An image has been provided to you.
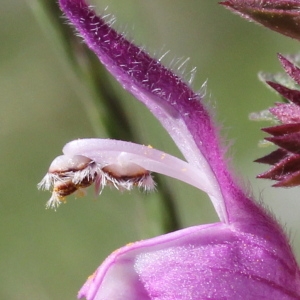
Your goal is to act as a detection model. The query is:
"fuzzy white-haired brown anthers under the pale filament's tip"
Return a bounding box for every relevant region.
[38,155,155,209]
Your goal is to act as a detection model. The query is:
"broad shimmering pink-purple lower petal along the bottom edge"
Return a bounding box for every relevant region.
[78,223,300,300]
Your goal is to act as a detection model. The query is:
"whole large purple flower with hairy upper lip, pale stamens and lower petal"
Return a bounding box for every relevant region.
[41,0,300,300]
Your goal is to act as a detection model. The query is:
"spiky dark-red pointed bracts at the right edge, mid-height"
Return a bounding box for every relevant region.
[256,55,300,187]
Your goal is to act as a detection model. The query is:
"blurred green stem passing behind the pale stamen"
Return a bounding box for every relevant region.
[28,0,181,232]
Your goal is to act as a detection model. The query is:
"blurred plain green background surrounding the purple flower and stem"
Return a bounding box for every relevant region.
[0,0,300,300]
